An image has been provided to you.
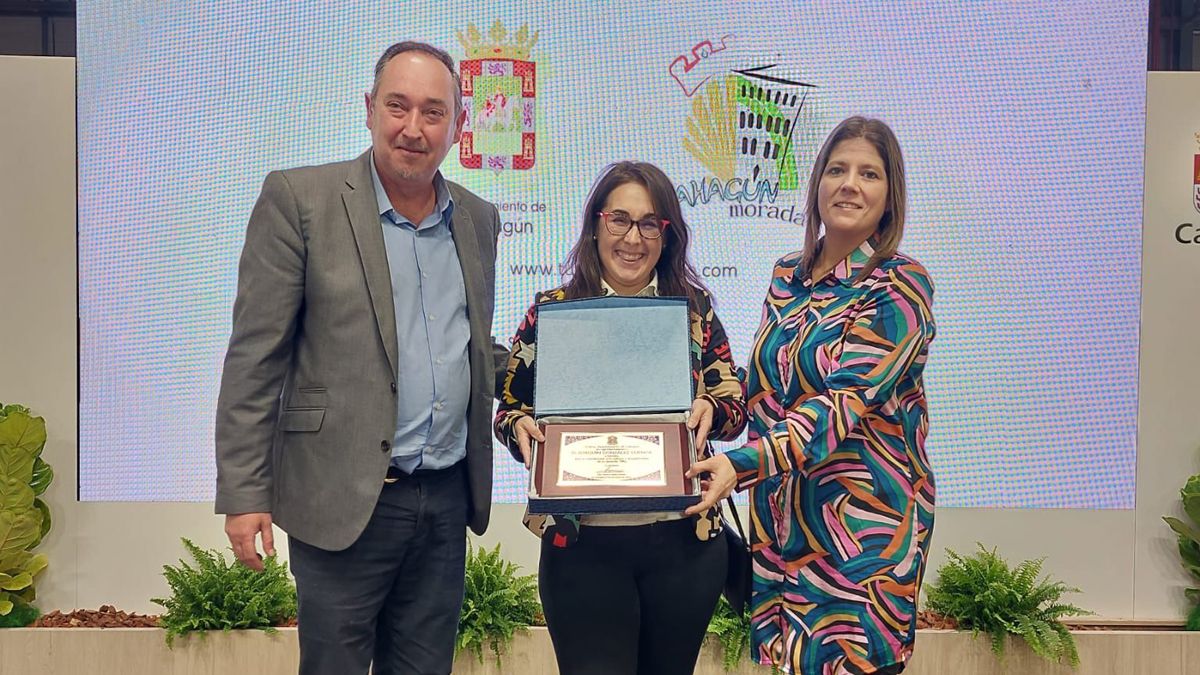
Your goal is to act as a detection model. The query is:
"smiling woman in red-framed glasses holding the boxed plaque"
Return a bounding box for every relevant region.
[496,162,745,675]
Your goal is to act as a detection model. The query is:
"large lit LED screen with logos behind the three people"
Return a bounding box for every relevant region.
[78,0,1146,508]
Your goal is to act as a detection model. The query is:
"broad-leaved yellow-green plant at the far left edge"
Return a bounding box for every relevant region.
[0,404,54,627]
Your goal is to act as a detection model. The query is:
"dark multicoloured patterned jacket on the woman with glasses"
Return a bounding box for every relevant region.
[494,281,746,546]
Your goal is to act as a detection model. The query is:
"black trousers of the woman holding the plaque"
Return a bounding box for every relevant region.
[538,518,728,675]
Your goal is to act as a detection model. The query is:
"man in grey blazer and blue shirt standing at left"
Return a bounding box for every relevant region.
[216,42,504,675]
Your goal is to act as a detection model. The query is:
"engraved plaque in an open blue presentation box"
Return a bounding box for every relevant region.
[529,297,700,513]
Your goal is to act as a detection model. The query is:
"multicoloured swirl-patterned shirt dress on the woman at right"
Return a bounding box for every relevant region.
[728,241,935,675]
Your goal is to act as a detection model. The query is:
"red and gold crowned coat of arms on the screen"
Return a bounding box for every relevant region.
[458,20,538,171]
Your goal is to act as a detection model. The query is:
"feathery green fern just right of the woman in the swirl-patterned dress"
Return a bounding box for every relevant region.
[925,544,1091,667]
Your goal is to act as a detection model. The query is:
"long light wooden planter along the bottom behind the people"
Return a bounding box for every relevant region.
[0,628,1200,675]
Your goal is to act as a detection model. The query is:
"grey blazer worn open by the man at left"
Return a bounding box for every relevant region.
[216,153,506,550]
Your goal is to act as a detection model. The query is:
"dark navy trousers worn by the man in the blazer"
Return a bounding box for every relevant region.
[288,462,468,675]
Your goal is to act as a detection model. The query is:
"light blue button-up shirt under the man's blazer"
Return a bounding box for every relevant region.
[371,156,470,473]
